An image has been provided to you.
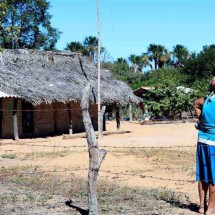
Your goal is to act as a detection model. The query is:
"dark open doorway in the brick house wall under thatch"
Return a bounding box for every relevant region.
[22,101,34,137]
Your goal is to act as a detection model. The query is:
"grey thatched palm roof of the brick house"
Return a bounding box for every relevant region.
[0,49,139,105]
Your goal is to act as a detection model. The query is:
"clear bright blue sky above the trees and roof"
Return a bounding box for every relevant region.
[49,0,215,59]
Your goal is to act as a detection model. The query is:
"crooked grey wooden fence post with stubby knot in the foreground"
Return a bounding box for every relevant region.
[81,84,107,215]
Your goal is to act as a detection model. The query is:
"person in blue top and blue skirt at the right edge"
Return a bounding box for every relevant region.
[194,77,215,215]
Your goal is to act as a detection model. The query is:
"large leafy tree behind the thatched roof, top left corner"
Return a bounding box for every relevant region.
[0,0,60,49]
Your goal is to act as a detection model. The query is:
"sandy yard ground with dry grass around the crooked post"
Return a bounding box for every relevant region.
[0,123,198,215]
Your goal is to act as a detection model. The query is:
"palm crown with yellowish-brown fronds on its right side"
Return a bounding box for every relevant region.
[147,44,170,69]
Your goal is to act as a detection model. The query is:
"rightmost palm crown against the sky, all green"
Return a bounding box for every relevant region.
[172,45,189,66]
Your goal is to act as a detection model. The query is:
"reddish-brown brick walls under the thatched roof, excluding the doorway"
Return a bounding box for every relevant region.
[2,98,98,138]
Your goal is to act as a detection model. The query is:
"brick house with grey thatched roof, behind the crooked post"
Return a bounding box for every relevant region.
[0,49,140,138]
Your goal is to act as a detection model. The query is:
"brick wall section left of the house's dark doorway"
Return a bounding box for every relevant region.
[2,98,22,138]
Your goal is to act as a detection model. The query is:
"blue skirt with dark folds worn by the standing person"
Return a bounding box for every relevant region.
[196,143,215,185]
